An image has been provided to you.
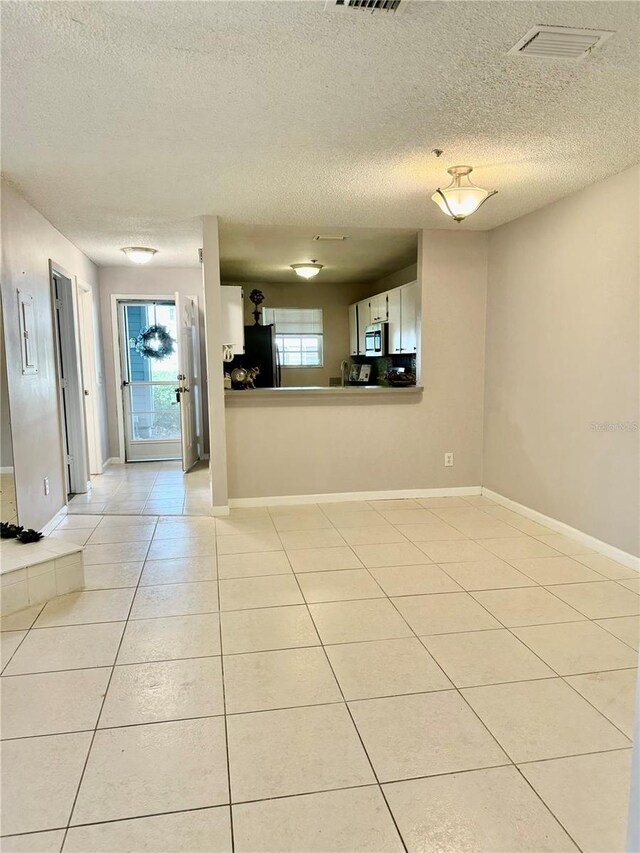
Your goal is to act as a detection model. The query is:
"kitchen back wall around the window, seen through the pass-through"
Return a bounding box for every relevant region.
[225,276,396,387]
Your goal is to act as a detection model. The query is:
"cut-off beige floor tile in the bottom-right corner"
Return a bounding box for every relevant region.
[520,749,631,853]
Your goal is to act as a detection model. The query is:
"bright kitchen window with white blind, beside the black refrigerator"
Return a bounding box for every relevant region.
[262,308,323,367]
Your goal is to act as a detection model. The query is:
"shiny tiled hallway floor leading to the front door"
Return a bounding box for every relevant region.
[69,461,211,516]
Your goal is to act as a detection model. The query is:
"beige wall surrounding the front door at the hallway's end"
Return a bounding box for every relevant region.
[98,270,209,457]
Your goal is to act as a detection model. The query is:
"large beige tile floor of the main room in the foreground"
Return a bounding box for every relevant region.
[1,496,640,853]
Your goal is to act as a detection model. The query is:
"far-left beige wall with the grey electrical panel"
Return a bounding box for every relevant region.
[2,183,97,529]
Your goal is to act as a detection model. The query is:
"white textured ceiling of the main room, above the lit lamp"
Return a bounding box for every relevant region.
[0,0,640,266]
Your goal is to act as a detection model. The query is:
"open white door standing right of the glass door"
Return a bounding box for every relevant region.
[176,293,200,471]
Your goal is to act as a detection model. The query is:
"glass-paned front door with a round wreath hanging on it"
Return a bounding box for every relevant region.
[118,300,182,462]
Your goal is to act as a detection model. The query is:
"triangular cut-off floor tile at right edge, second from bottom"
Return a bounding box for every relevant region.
[567,661,638,738]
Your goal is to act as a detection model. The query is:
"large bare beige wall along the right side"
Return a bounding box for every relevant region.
[483,167,640,554]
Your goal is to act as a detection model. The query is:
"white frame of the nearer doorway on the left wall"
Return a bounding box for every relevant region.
[49,258,91,502]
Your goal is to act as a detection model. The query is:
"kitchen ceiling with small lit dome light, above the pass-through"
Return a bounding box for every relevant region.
[220,222,418,284]
